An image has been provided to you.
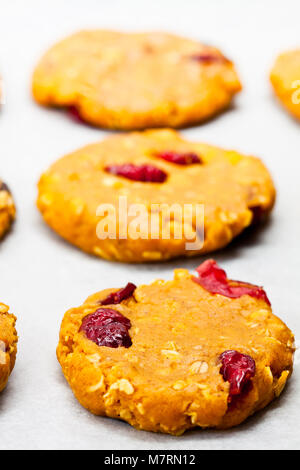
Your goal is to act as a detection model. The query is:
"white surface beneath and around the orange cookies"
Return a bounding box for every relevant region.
[0,0,300,449]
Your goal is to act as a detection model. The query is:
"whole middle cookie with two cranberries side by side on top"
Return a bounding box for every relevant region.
[38,130,275,262]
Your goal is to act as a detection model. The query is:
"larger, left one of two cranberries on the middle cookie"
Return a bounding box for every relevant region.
[105,163,167,183]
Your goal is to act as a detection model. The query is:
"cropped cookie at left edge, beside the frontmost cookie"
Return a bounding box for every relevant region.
[0,303,18,392]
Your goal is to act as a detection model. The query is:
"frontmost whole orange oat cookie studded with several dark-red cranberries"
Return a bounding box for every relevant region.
[57,260,294,434]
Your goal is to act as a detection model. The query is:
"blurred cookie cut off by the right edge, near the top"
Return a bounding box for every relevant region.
[270,49,300,119]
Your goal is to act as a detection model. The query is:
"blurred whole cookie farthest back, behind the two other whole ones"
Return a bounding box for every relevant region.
[33,31,241,129]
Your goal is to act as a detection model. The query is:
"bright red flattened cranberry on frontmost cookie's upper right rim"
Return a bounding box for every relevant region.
[193,259,271,305]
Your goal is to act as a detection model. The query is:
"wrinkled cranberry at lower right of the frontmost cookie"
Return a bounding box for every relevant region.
[219,350,256,403]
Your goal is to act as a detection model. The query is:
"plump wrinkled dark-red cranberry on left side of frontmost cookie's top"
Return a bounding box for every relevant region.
[79,308,132,348]
